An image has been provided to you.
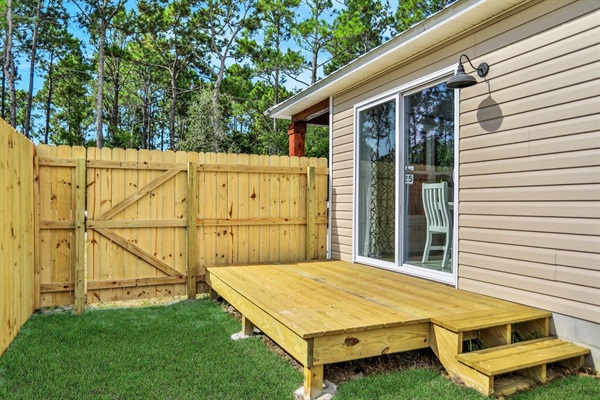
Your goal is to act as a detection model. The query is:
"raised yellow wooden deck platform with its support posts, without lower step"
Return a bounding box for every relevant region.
[206,261,584,398]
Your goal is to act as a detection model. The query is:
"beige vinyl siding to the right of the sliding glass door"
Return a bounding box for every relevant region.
[458,4,600,323]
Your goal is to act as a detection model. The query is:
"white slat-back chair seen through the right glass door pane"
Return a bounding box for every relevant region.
[422,182,452,269]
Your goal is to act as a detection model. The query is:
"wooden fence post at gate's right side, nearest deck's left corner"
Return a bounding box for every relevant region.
[186,162,198,299]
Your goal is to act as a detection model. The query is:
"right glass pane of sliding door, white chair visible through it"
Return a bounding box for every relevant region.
[402,83,454,272]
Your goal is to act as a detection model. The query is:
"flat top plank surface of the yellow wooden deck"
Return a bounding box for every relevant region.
[208,261,524,339]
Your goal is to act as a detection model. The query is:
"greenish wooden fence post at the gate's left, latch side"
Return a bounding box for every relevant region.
[75,158,86,314]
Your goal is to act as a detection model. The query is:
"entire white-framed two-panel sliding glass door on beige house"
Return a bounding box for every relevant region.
[354,77,455,281]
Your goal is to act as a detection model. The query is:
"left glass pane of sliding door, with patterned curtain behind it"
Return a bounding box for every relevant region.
[356,99,396,262]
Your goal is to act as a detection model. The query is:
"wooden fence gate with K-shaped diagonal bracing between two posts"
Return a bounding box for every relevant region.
[87,148,188,303]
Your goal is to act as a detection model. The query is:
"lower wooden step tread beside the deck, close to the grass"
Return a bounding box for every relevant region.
[456,338,590,376]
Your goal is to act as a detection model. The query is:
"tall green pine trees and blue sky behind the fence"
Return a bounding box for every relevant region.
[0,0,450,157]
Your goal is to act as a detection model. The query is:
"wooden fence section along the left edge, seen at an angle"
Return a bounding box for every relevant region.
[0,119,35,354]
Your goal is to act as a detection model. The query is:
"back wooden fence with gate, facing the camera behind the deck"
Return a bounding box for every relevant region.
[36,145,328,311]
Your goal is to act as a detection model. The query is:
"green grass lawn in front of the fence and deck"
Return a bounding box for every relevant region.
[0,300,600,400]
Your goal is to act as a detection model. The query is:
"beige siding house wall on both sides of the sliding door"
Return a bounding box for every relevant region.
[331,1,600,365]
